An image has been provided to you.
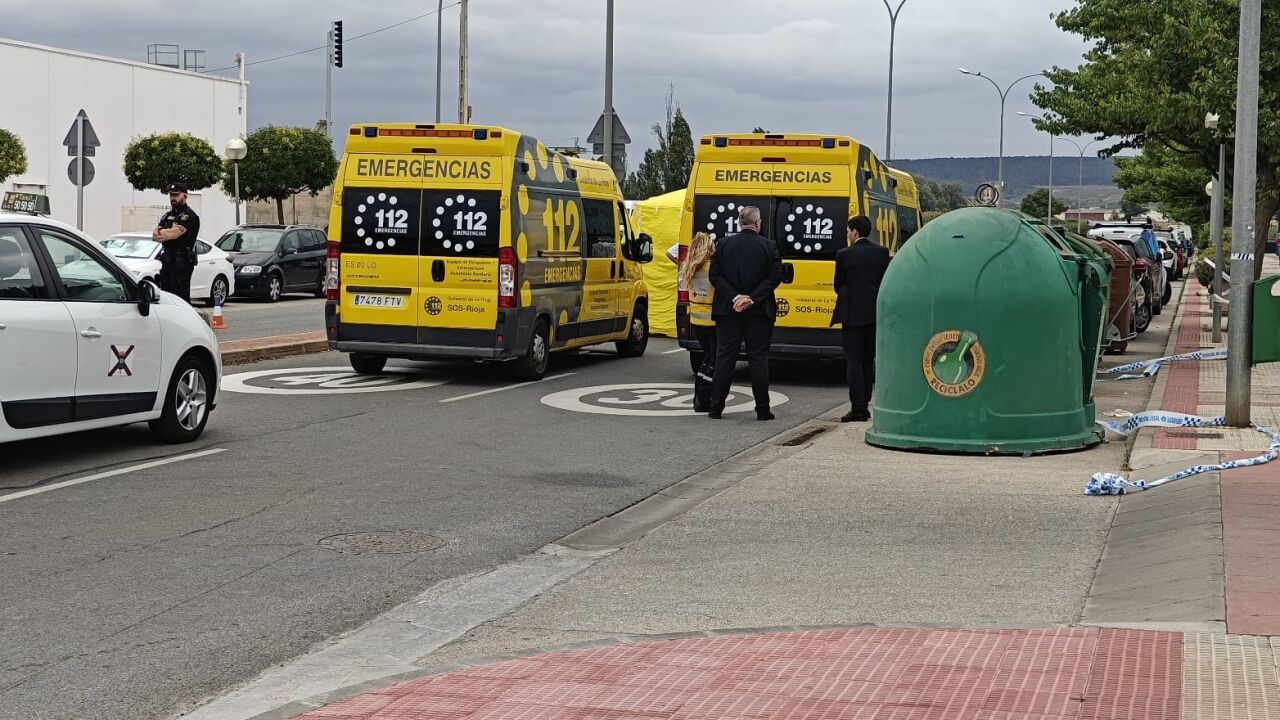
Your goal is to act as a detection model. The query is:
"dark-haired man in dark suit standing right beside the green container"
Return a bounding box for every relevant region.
[831,215,888,423]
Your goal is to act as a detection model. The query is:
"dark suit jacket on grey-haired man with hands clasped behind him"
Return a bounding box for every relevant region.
[710,231,782,319]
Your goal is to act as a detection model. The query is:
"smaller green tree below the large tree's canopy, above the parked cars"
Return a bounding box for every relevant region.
[1115,145,1212,225]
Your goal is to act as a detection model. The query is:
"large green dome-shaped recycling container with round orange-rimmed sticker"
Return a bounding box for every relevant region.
[867,208,1110,454]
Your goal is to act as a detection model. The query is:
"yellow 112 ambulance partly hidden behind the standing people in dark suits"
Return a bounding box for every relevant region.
[676,133,920,370]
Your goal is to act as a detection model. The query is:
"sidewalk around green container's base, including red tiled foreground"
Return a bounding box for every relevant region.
[189,271,1280,720]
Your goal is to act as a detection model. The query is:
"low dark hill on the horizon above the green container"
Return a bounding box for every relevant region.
[893,155,1123,206]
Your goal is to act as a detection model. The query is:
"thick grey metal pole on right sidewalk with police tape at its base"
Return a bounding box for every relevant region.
[1226,0,1262,428]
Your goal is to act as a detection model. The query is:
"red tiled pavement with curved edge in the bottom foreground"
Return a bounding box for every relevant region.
[302,628,1183,720]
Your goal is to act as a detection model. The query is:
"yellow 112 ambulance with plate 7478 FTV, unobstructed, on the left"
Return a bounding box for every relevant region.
[325,124,653,379]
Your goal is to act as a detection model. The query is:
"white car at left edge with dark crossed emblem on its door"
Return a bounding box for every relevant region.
[0,213,223,443]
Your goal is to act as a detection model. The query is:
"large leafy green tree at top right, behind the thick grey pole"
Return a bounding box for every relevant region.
[1033,0,1280,275]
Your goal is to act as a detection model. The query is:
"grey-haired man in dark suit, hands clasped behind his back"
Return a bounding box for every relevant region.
[708,206,782,420]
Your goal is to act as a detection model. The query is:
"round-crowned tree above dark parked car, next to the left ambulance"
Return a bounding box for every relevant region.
[223,126,338,224]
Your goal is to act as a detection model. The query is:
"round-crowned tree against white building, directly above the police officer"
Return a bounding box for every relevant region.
[124,132,223,192]
